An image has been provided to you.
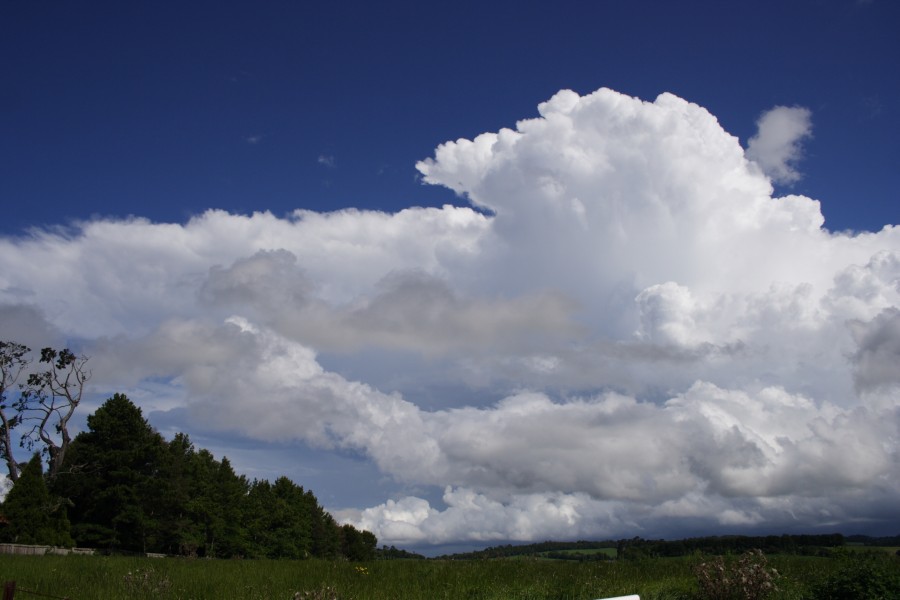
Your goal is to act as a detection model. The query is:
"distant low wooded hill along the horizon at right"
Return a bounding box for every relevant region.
[441,533,856,560]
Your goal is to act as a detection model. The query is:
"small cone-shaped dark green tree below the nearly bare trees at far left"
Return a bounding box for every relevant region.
[0,453,75,546]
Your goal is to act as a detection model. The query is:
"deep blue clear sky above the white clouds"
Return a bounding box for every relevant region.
[0,0,900,234]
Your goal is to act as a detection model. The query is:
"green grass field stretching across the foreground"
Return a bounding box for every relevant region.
[0,555,897,600]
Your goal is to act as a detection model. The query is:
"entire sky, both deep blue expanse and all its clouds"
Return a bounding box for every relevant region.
[0,0,900,552]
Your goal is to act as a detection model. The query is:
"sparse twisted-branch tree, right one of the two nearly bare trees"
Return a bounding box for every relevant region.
[16,348,91,479]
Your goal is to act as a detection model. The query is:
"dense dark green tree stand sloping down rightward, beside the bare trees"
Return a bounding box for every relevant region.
[46,394,377,561]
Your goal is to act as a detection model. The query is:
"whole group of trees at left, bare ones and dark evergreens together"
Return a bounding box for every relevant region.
[0,342,377,560]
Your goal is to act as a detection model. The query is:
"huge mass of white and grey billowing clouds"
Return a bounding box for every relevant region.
[0,89,900,544]
